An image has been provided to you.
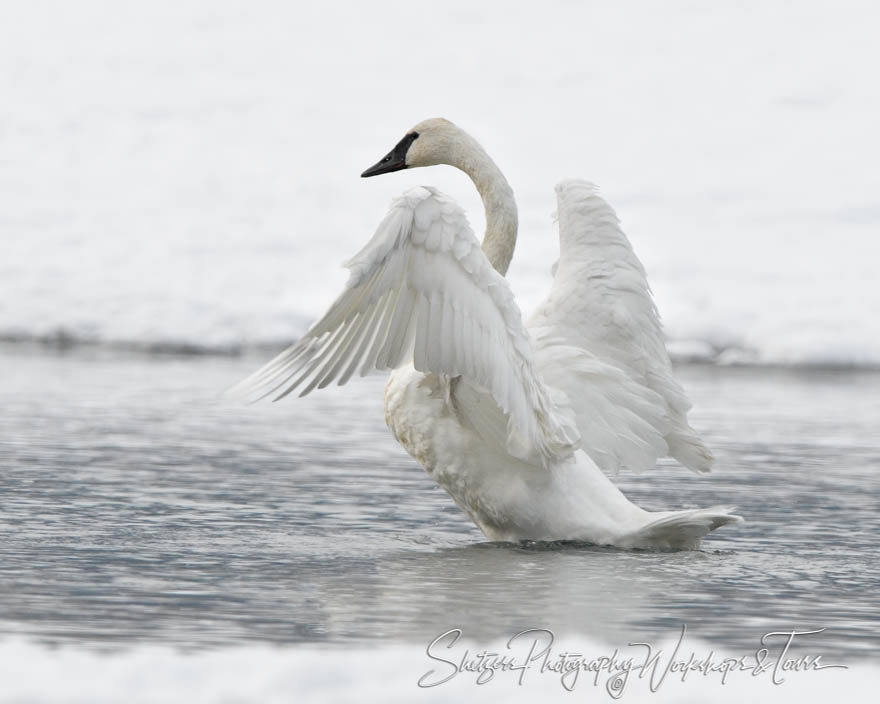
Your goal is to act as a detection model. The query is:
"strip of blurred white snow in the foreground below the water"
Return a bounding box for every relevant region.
[0,634,880,704]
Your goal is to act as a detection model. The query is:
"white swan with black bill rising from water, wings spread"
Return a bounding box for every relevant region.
[230,118,742,549]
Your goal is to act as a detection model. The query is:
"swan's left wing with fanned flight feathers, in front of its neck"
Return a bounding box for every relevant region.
[230,188,578,465]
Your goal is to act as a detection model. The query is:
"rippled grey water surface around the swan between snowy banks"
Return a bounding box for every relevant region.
[0,346,880,655]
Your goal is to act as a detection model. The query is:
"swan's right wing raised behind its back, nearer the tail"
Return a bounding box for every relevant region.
[528,180,712,472]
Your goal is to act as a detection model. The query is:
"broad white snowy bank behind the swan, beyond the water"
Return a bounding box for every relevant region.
[0,0,880,366]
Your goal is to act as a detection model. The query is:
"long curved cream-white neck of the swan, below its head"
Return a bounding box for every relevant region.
[450,131,519,276]
